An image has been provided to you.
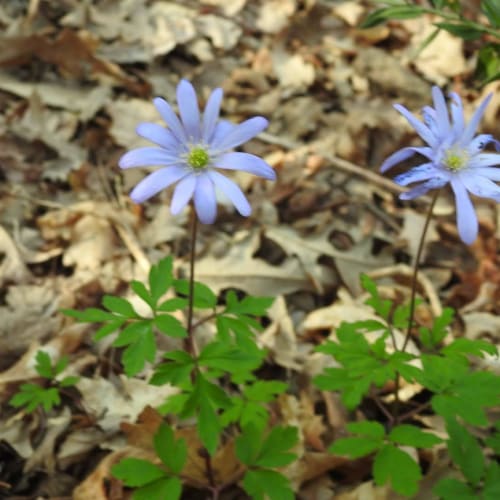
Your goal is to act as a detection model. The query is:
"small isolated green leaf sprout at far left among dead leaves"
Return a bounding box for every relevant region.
[9,351,79,413]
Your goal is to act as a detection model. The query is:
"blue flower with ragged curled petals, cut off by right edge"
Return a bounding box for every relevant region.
[380,87,500,245]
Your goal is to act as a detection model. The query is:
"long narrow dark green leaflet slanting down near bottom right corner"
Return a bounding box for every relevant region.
[446,418,485,486]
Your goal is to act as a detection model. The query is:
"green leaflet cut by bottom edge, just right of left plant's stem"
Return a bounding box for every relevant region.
[243,470,295,500]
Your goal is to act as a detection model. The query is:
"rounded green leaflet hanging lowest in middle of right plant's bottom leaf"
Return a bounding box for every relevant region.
[373,444,422,496]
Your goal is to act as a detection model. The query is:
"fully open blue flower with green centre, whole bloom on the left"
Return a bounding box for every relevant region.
[119,80,276,224]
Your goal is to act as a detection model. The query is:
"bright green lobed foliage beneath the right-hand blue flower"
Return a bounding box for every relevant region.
[314,276,500,500]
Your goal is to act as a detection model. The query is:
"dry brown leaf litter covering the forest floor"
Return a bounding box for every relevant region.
[0,0,500,500]
